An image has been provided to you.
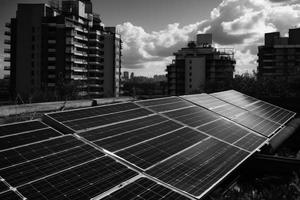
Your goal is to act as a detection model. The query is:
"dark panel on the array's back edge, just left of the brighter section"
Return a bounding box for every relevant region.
[136,97,193,112]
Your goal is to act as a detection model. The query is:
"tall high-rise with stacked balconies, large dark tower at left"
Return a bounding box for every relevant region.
[5,0,121,98]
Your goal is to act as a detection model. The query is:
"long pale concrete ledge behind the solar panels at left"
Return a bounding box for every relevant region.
[0,97,133,117]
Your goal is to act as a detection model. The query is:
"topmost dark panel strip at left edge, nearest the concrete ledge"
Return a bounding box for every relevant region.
[0,121,47,137]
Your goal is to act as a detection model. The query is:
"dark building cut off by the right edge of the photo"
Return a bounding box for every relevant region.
[257,28,300,81]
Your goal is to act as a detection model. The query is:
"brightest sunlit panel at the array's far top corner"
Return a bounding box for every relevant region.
[210,90,258,108]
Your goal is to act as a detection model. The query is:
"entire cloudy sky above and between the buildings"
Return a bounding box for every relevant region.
[0,0,300,76]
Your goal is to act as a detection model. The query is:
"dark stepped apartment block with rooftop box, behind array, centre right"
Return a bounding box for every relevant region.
[167,34,235,95]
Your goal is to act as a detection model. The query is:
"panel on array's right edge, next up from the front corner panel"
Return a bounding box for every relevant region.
[198,118,267,152]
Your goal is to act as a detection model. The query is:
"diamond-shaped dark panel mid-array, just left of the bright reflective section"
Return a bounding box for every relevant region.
[164,106,220,127]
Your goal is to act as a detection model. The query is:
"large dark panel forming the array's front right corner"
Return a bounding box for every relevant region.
[147,138,249,196]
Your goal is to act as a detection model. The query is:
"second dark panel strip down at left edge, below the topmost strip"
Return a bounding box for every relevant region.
[0,128,61,150]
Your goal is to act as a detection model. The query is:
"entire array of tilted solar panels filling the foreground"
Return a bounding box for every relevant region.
[0,91,294,200]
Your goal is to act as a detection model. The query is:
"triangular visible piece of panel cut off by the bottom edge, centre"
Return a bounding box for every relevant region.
[102,177,190,200]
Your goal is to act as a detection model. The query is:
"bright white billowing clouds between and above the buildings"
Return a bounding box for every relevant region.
[118,0,300,75]
